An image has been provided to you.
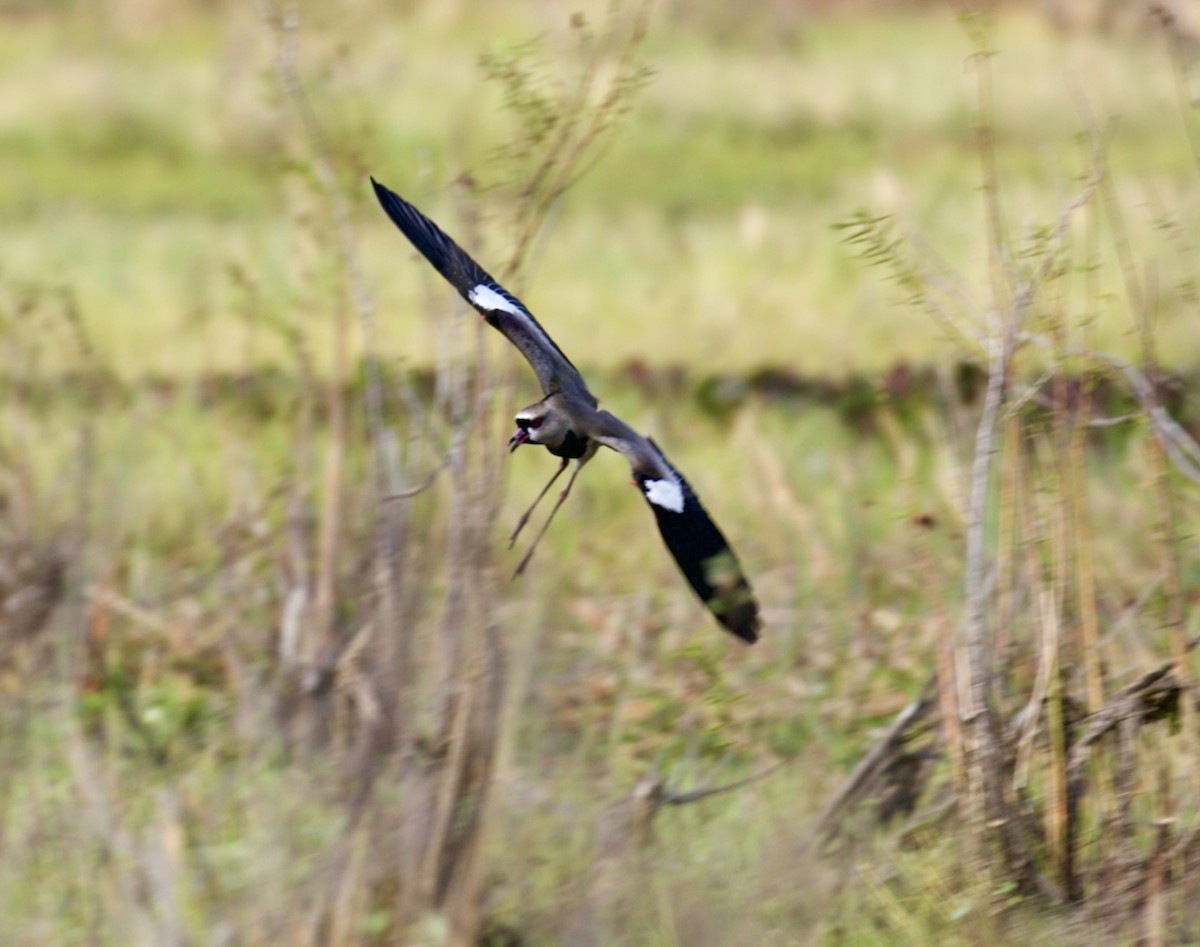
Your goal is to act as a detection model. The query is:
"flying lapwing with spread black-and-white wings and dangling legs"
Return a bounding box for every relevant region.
[371,178,760,642]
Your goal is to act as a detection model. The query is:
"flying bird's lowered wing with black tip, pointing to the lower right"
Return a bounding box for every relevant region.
[588,410,762,645]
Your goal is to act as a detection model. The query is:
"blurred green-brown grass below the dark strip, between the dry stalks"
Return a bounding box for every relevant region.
[7,367,1180,943]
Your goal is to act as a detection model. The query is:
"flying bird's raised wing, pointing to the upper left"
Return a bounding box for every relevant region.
[371,178,596,404]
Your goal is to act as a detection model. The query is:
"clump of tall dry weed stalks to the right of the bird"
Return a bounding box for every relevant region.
[847,10,1200,942]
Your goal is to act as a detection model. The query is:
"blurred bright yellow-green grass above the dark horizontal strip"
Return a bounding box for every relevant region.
[9,4,1195,376]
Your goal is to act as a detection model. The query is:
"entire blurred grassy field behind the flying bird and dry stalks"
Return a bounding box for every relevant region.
[0,0,1200,945]
